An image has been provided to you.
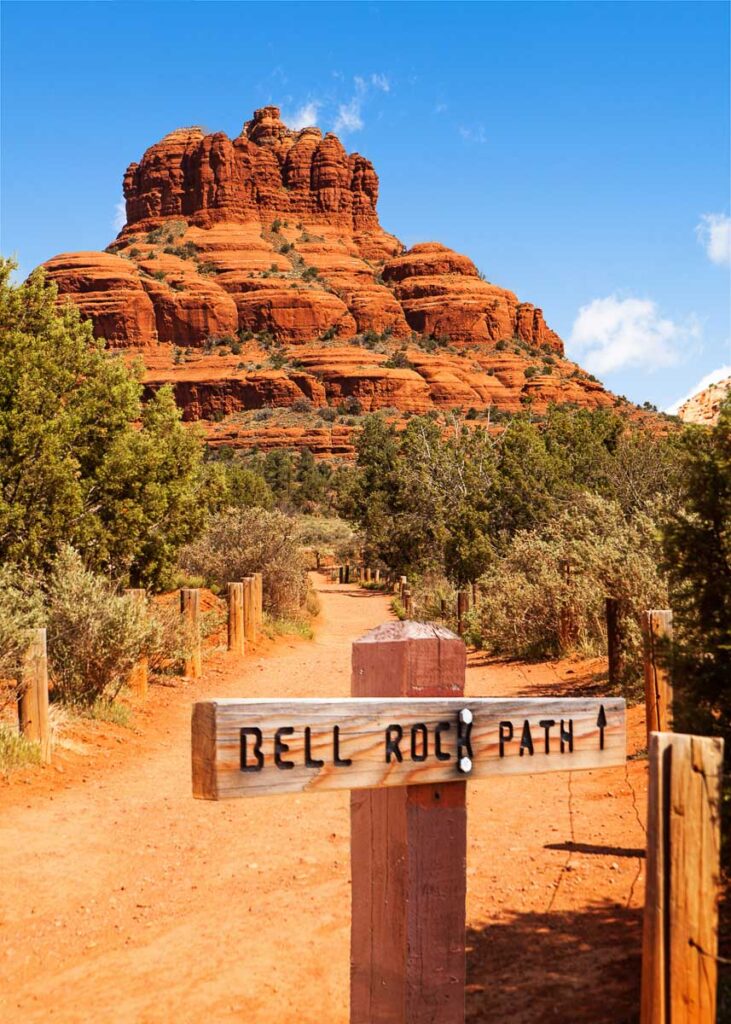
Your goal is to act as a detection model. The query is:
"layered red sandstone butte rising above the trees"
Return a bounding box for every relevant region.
[39,106,619,454]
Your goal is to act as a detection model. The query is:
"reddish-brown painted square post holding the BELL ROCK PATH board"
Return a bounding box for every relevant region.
[350,623,467,1024]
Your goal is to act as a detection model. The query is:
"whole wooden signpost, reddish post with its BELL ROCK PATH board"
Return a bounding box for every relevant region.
[192,622,626,1024]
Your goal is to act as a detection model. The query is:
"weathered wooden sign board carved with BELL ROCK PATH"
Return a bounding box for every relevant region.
[192,697,626,800]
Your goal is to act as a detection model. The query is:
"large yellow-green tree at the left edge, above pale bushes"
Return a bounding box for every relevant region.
[0,260,205,587]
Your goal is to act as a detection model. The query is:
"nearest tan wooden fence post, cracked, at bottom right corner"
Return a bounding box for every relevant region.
[641,732,723,1024]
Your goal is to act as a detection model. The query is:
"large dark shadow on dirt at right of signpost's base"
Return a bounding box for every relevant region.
[466,902,642,1024]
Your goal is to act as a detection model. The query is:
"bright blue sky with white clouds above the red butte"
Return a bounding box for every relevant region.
[0,0,731,408]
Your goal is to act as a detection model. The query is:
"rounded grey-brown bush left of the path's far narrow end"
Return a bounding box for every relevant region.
[180,508,307,615]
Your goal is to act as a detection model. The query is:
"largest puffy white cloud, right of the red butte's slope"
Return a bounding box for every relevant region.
[568,295,700,374]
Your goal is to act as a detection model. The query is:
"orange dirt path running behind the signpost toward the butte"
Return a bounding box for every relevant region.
[0,583,644,1024]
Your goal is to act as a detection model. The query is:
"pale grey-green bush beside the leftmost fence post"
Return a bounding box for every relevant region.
[46,548,153,706]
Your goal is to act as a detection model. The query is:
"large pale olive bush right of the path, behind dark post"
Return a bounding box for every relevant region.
[473,494,668,677]
